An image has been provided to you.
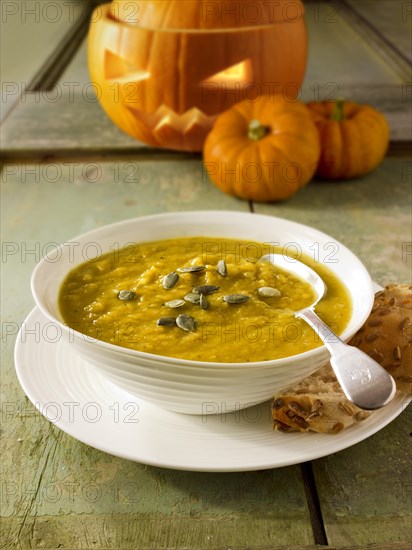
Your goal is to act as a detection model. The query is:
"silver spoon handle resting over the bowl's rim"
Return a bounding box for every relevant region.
[296,308,396,410]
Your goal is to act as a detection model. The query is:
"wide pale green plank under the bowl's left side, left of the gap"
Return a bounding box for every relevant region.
[0,161,314,549]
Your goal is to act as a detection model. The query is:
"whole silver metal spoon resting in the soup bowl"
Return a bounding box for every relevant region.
[261,254,396,410]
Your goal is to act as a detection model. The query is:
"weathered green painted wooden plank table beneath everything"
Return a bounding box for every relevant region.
[1,0,412,550]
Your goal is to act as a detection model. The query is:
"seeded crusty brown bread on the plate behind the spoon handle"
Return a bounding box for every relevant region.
[272,284,412,433]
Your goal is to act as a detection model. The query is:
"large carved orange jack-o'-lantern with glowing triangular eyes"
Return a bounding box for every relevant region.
[89,0,307,151]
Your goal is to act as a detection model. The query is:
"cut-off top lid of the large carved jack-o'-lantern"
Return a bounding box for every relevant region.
[110,0,304,30]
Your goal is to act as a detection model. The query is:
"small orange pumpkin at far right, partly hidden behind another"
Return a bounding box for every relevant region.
[307,100,389,180]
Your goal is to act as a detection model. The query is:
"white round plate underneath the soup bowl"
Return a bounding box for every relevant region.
[15,308,410,472]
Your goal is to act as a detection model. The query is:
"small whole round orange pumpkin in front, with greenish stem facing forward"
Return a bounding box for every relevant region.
[204,95,320,201]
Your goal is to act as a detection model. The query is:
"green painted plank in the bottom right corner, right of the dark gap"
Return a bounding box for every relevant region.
[313,414,412,546]
